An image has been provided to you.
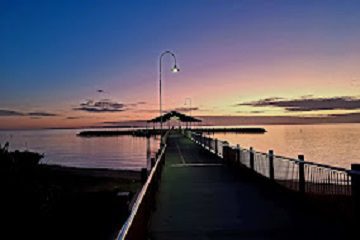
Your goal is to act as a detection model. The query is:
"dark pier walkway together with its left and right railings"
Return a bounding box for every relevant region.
[117,131,360,240]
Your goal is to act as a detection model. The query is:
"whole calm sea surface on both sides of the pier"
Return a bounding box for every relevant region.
[0,124,360,170]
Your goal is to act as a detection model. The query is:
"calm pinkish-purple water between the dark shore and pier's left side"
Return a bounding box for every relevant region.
[0,130,159,170]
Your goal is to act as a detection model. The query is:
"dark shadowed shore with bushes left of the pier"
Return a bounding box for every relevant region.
[0,144,140,240]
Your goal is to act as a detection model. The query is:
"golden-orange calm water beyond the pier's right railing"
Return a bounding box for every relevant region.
[208,124,360,168]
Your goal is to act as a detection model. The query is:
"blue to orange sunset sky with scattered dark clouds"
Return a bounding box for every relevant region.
[0,0,360,129]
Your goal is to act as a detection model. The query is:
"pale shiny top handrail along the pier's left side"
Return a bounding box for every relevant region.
[116,144,167,240]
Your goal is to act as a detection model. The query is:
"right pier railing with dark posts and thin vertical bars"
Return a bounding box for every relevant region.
[185,131,353,197]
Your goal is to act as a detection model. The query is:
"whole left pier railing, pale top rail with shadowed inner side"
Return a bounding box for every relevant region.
[116,131,169,240]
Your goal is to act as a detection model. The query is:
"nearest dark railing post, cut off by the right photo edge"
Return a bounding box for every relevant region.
[351,164,360,218]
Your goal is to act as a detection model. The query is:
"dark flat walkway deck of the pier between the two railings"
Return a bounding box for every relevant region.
[149,134,346,240]
